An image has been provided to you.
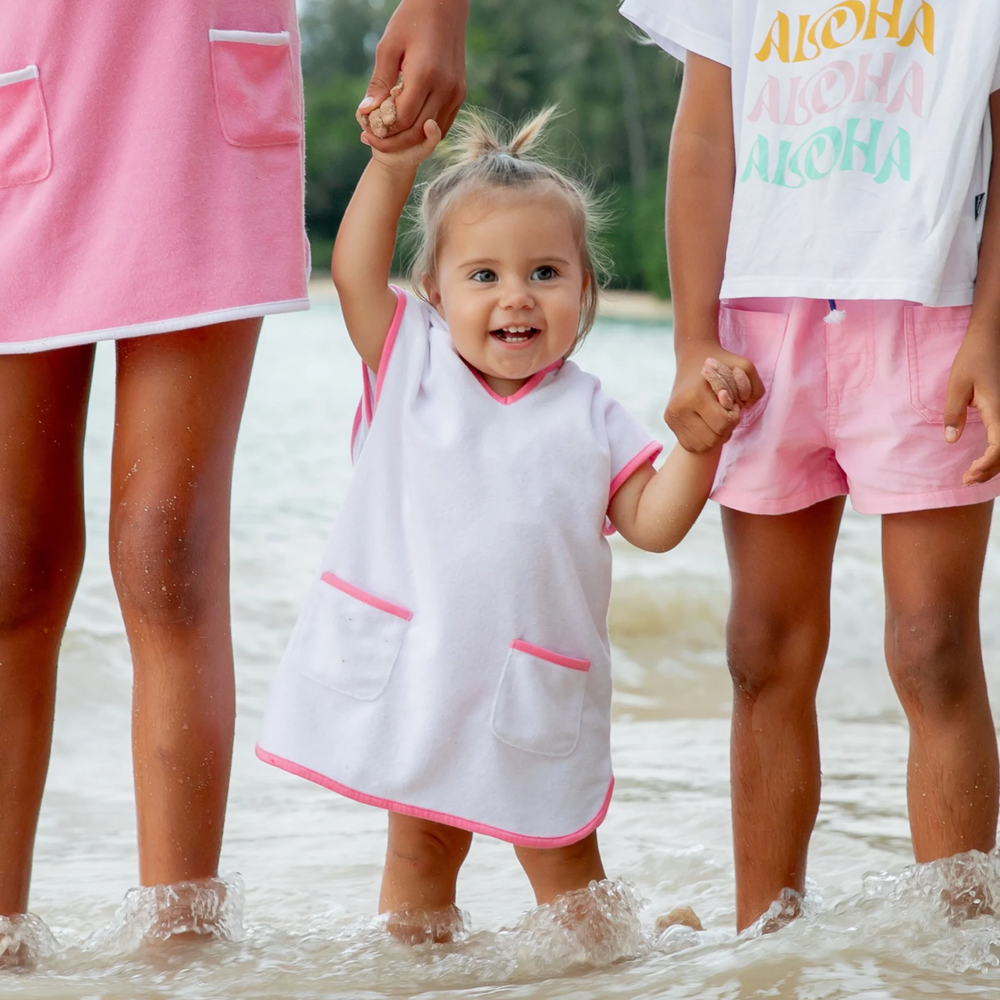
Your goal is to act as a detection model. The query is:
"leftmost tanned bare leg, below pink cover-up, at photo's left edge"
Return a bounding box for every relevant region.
[0,347,94,916]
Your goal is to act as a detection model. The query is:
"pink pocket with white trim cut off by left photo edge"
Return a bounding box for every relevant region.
[0,66,52,188]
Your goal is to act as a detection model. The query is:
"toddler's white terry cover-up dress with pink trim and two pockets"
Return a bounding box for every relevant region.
[257,292,661,847]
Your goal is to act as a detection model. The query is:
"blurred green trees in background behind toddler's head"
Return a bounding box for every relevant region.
[302,0,681,296]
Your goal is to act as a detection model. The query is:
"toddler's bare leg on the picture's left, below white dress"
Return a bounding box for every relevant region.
[378,812,472,944]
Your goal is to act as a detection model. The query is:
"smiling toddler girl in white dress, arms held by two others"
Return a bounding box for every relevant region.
[257,105,739,939]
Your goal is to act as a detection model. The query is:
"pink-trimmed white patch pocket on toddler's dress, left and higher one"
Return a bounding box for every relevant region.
[288,573,413,701]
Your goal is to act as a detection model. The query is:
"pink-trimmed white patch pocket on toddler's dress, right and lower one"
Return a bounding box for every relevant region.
[490,639,590,757]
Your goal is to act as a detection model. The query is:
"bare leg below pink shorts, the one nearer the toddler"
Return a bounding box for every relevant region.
[723,498,844,930]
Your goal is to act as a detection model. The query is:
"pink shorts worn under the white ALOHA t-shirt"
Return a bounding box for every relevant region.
[712,299,1000,514]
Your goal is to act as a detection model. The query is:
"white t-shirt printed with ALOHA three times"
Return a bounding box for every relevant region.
[621,0,1000,306]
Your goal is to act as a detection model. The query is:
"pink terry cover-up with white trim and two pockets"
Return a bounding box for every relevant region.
[0,0,308,353]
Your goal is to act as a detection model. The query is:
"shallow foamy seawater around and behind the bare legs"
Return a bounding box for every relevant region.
[7,302,1000,1000]
